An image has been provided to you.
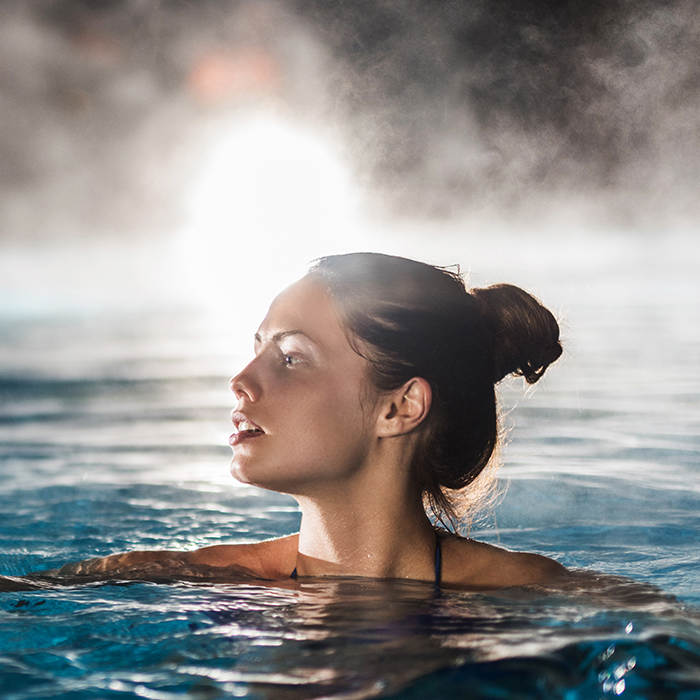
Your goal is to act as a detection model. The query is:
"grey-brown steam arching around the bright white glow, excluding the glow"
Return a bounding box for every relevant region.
[0,0,700,245]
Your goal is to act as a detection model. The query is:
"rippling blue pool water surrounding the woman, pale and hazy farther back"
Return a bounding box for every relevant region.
[0,235,700,700]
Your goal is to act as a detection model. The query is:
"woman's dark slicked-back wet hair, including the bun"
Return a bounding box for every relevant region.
[308,253,562,529]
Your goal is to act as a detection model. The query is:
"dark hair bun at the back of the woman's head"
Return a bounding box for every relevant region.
[470,284,562,384]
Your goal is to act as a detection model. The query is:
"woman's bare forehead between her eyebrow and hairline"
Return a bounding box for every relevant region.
[258,277,349,347]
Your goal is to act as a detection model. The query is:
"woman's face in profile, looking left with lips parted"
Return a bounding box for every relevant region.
[230,278,375,495]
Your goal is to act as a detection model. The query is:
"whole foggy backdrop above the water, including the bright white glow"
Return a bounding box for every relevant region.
[0,0,700,318]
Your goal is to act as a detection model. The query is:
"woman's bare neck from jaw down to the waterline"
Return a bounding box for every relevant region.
[297,464,435,581]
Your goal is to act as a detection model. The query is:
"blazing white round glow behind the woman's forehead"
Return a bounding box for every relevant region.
[177,116,363,334]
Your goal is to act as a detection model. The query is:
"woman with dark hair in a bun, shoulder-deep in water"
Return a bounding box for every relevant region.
[2,253,566,590]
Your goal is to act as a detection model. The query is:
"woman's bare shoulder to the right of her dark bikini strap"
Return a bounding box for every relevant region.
[443,535,568,590]
